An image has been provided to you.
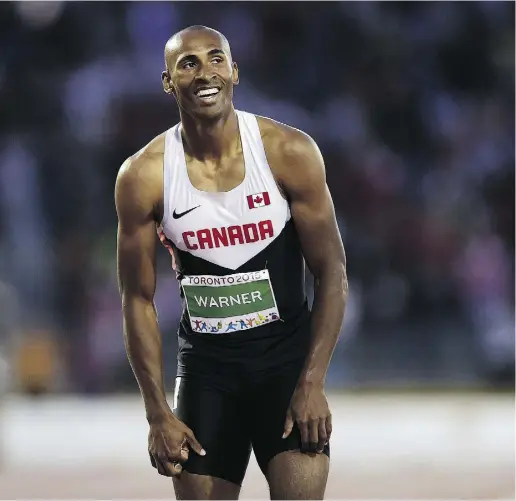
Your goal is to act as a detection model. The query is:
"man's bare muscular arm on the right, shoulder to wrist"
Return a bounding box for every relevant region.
[280,131,348,386]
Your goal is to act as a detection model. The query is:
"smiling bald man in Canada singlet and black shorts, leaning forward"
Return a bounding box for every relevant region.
[115,26,347,499]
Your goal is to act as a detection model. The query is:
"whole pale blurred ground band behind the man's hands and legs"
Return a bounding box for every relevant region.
[0,394,515,500]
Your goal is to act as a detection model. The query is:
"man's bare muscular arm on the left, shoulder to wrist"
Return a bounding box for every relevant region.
[115,158,170,422]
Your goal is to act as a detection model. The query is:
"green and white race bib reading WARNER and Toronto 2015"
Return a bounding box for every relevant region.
[181,270,280,334]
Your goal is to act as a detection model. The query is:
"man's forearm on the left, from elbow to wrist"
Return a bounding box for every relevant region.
[123,298,170,422]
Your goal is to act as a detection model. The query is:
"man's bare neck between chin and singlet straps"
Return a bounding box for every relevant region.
[181,106,239,160]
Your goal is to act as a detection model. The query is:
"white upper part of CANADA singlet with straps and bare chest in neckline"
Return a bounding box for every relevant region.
[161,116,290,270]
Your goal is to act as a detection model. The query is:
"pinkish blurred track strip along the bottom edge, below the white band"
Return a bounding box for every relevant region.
[0,460,514,500]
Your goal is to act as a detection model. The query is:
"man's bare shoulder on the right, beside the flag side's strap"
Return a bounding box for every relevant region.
[257,116,326,191]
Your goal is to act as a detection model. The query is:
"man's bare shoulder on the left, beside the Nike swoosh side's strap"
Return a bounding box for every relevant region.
[115,133,165,222]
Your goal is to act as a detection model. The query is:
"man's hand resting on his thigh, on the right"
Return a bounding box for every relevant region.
[283,384,331,453]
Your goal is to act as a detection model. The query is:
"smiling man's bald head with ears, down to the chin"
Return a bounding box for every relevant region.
[162,27,238,119]
